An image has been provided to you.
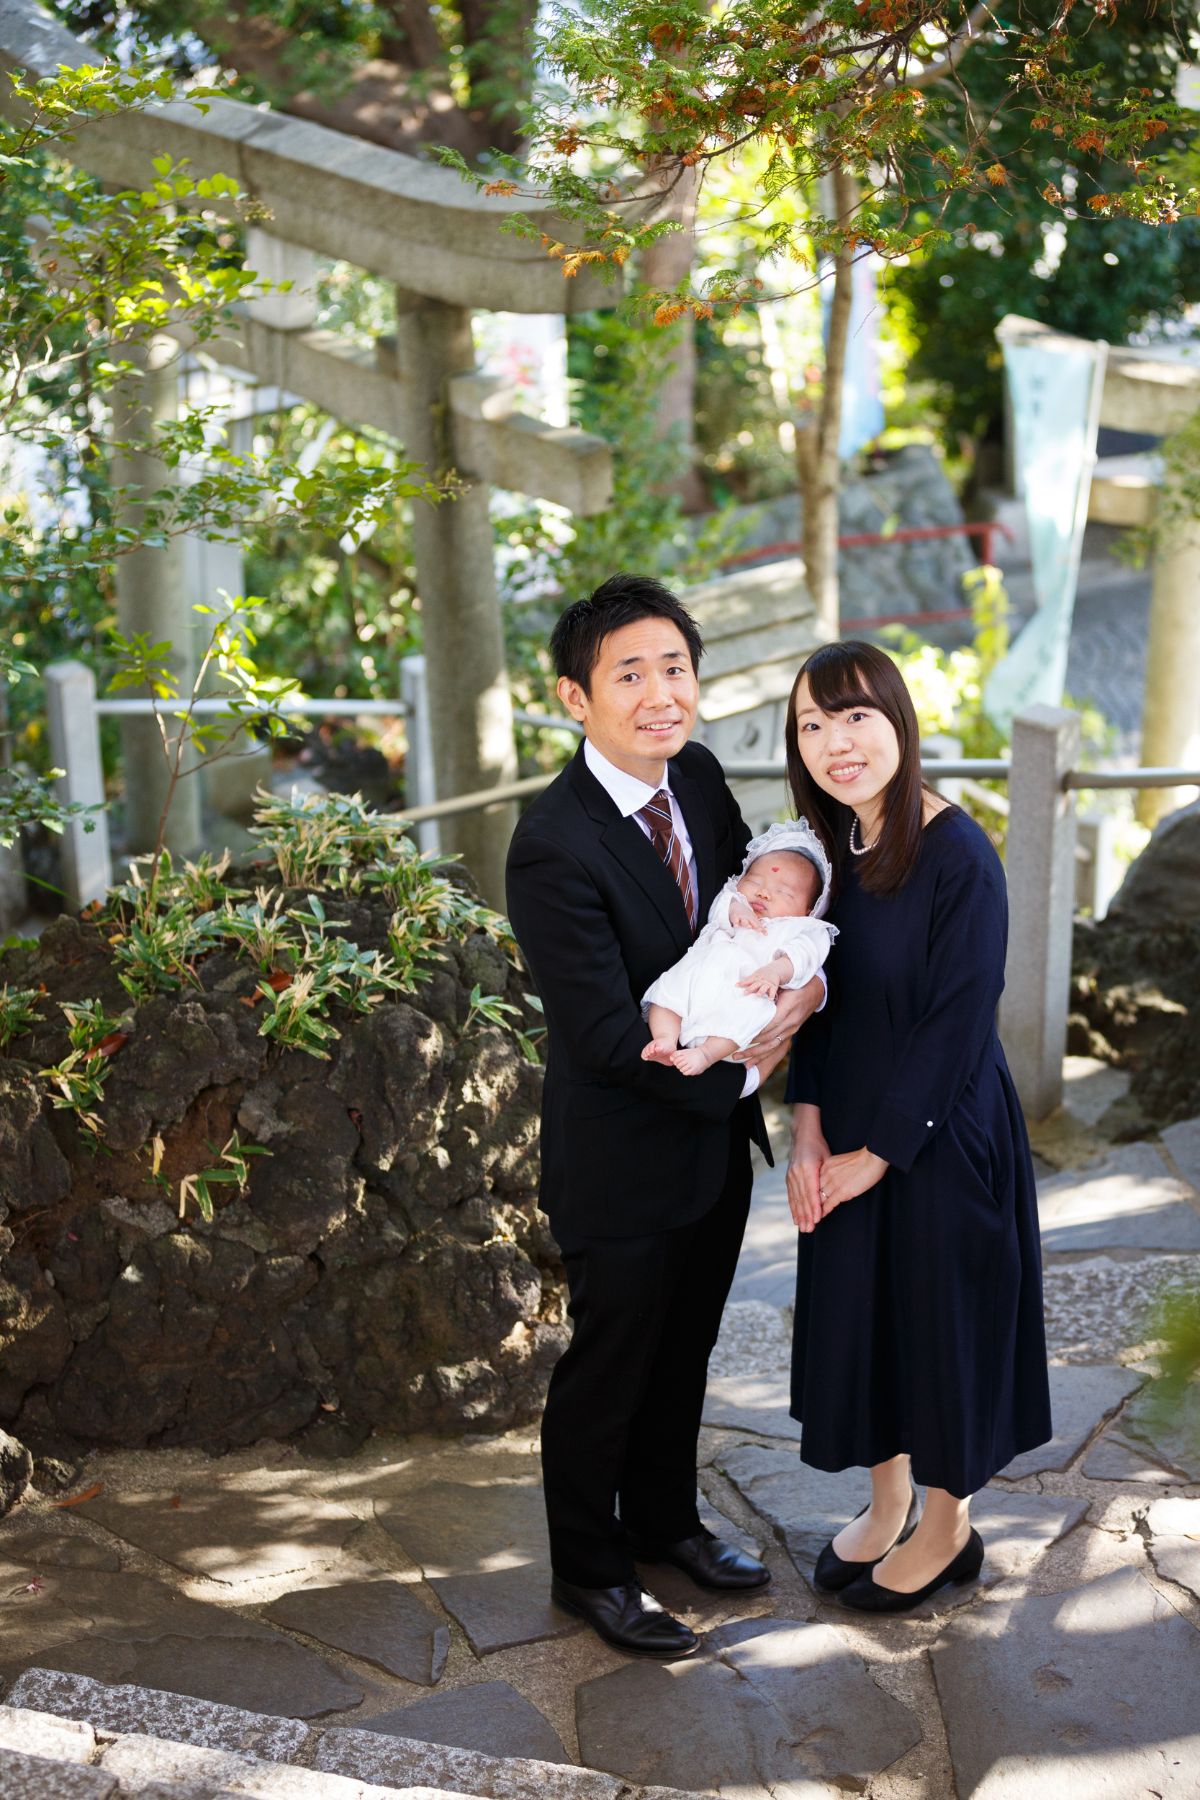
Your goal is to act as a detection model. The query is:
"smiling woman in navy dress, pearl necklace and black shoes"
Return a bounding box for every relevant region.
[786,643,1051,1613]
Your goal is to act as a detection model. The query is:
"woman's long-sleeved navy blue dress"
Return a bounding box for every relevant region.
[788,808,1051,1498]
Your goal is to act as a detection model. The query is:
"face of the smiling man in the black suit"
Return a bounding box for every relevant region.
[558,617,700,787]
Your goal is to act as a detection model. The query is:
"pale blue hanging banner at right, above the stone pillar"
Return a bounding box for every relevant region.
[984,315,1108,731]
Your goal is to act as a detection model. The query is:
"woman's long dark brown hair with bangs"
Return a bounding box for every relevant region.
[784,639,923,895]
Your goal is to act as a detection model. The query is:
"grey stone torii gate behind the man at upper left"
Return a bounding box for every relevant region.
[0,0,615,900]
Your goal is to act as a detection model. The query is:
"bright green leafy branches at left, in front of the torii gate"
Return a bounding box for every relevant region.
[0,65,439,860]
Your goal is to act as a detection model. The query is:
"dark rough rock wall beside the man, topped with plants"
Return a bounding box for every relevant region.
[0,885,565,1451]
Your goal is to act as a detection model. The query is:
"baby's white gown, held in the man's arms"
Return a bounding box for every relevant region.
[642,878,837,1049]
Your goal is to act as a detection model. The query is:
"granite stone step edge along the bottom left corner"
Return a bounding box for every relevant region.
[0,1669,694,1800]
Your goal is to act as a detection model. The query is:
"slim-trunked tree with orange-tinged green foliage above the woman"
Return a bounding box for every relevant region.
[446,0,1195,626]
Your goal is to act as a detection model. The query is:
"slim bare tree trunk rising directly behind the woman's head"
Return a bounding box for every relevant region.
[795,169,858,639]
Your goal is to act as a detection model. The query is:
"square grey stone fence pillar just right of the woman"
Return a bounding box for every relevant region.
[1000,706,1079,1120]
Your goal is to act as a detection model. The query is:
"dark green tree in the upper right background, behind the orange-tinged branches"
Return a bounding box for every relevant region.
[889,0,1200,464]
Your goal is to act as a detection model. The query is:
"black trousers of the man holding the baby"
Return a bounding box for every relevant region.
[542,1121,752,1588]
